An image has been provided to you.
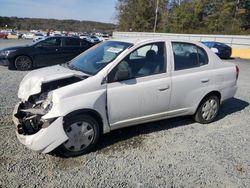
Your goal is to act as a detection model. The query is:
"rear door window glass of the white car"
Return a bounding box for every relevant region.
[172,42,208,70]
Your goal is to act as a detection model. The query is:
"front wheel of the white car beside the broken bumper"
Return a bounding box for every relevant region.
[56,114,100,157]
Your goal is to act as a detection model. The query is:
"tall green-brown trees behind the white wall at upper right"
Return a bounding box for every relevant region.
[116,0,250,34]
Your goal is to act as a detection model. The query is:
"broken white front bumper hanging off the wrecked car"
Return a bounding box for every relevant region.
[12,103,68,153]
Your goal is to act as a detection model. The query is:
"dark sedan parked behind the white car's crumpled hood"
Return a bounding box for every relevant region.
[0,36,94,70]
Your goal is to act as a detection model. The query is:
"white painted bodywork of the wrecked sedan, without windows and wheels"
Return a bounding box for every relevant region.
[14,39,237,153]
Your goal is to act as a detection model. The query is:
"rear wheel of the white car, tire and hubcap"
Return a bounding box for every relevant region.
[194,95,220,124]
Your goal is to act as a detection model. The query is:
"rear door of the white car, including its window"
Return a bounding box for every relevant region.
[170,42,212,115]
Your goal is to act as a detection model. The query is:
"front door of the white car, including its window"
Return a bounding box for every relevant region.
[107,42,171,129]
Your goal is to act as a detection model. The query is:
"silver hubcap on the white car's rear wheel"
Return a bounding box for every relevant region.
[201,99,218,121]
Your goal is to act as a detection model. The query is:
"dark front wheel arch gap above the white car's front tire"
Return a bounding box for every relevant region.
[63,109,103,134]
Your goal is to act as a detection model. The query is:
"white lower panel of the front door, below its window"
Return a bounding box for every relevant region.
[107,73,171,129]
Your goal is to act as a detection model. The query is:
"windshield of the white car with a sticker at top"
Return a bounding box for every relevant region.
[68,41,132,75]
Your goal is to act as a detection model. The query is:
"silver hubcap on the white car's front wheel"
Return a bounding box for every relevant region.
[64,121,94,151]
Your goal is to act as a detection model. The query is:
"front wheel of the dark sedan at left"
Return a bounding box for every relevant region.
[14,55,32,71]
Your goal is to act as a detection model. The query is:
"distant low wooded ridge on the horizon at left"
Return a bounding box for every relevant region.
[0,17,116,32]
